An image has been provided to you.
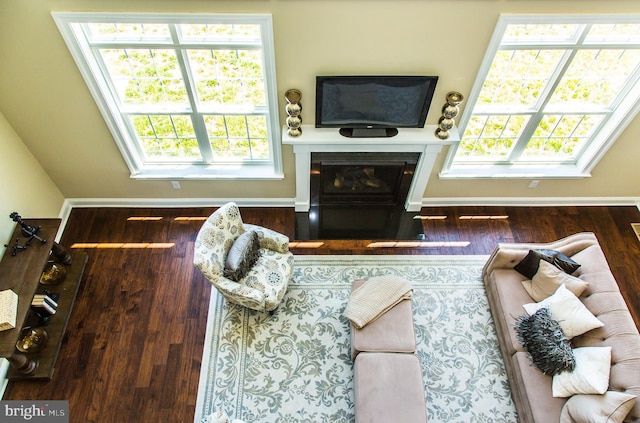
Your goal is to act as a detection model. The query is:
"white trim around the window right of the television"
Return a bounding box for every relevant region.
[439,14,640,179]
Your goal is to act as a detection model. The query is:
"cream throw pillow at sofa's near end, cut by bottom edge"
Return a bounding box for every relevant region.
[560,391,636,423]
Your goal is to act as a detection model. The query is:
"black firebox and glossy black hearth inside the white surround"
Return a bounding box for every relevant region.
[296,152,421,239]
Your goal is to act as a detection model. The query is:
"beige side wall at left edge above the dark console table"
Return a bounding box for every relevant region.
[0,113,64,257]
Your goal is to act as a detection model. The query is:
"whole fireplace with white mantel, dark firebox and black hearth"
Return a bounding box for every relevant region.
[282,125,460,240]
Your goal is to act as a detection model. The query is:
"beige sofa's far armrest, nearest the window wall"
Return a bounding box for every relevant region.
[482,232,598,277]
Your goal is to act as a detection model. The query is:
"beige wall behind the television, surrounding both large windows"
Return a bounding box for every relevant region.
[0,0,640,204]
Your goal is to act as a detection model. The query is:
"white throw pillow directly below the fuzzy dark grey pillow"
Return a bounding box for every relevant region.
[551,347,611,398]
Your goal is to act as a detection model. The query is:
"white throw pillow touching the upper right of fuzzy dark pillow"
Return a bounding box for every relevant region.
[523,285,604,339]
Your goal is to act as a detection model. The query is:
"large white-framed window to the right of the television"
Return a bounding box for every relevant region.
[441,15,640,178]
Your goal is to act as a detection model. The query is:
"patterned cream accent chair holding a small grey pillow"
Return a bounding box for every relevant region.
[194,203,293,311]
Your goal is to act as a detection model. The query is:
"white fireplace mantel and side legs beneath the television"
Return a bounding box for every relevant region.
[282,125,460,212]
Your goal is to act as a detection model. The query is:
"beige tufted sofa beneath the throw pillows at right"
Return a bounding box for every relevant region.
[483,232,640,423]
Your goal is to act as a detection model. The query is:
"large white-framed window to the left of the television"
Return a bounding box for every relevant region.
[53,13,282,179]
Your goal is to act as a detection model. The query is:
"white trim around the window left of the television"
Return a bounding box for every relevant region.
[51,12,284,179]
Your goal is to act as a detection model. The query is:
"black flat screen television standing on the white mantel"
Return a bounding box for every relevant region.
[316,76,438,137]
